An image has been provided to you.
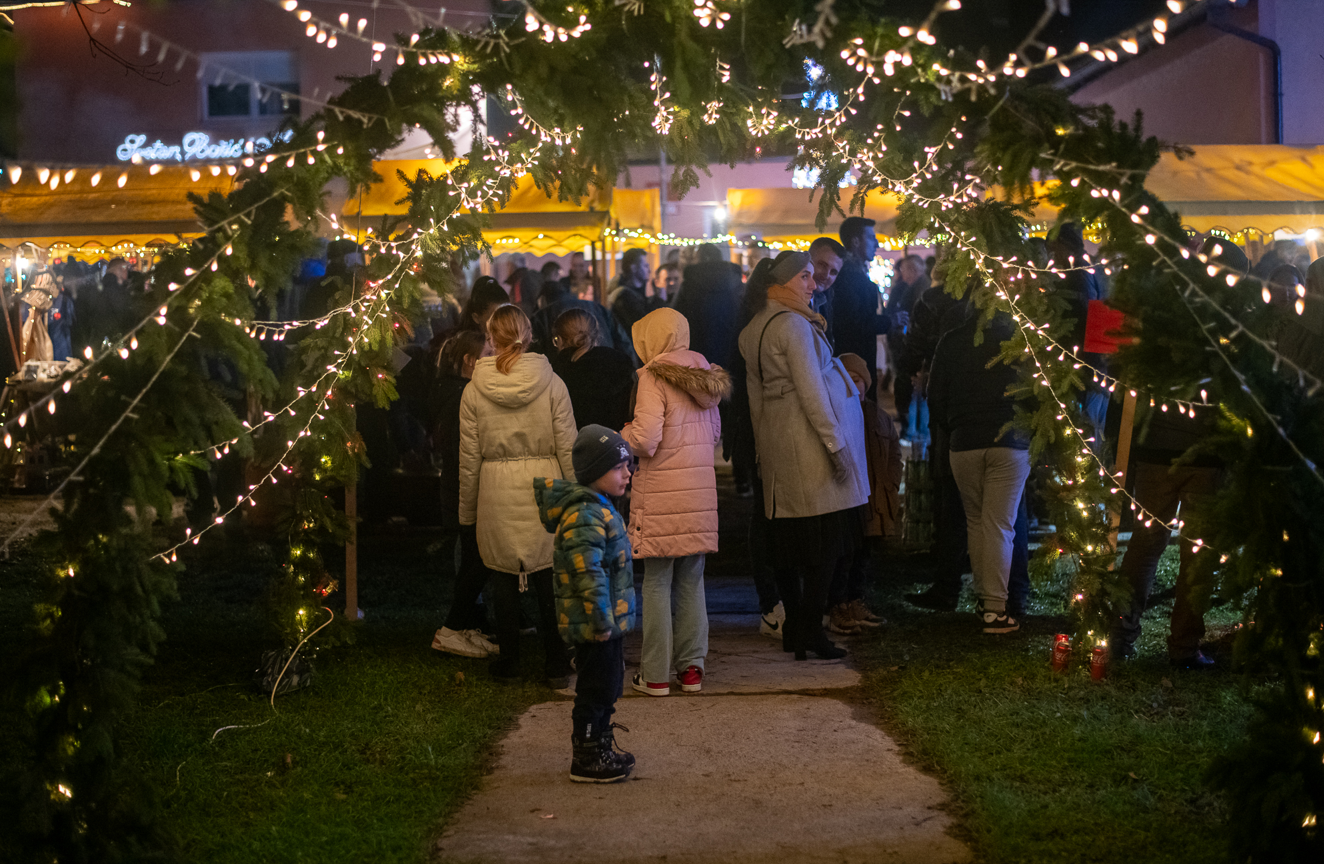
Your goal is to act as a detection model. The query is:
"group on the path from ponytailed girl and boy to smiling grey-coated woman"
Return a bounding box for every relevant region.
[407,218,906,782]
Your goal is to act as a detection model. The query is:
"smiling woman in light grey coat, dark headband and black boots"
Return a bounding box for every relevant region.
[739,253,869,660]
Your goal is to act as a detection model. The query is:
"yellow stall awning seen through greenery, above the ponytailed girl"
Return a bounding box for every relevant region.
[343,159,613,254]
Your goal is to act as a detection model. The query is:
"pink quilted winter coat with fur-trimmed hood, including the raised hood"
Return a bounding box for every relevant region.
[621,308,731,558]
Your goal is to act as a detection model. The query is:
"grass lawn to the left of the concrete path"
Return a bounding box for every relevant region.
[0,526,548,864]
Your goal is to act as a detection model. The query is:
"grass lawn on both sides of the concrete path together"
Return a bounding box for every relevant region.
[0,503,1249,864]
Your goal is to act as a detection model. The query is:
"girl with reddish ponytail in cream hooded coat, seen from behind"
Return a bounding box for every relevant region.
[459,304,576,689]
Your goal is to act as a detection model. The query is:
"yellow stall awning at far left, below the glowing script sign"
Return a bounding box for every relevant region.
[0,165,233,250]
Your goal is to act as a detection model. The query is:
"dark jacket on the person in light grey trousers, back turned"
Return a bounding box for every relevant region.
[928,304,1030,453]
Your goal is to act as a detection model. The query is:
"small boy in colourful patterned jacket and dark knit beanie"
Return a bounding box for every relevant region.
[534,426,634,783]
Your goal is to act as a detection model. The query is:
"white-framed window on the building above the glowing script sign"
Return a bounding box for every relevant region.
[199,52,299,120]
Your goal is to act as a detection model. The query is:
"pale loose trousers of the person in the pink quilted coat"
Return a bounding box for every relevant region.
[639,554,708,684]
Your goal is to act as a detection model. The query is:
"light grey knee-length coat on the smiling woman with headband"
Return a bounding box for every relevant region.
[739,300,869,519]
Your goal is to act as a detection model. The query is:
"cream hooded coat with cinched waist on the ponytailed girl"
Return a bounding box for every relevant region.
[459,355,576,573]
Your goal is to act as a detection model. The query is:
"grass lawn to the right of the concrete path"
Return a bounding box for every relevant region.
[857,549,1250,864]
